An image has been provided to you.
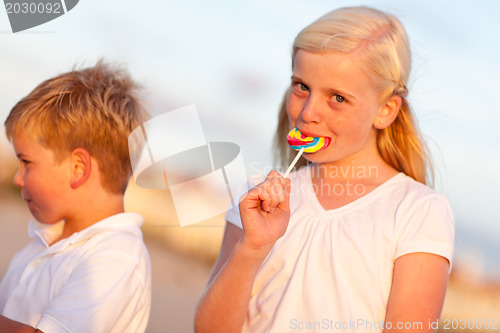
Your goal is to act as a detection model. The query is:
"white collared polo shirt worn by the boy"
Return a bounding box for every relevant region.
[0,213,151,333]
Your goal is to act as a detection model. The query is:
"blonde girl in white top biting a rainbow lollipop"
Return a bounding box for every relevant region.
[195,7,454,333]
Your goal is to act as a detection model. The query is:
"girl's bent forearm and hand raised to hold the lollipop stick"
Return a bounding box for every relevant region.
[194,171,290,333]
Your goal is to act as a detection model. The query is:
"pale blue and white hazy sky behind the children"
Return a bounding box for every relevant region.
[0,0,500,270]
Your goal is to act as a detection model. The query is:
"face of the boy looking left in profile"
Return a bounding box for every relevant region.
[12,135,71,224]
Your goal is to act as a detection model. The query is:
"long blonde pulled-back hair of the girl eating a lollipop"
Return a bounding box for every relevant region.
[275,6,432,184]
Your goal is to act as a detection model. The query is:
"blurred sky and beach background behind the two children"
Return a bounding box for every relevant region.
[0,0,500,332]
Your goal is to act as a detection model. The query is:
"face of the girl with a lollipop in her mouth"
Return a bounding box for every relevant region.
[287,50,382,163]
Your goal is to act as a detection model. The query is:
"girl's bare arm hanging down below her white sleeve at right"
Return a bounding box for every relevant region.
[384,252,449,332]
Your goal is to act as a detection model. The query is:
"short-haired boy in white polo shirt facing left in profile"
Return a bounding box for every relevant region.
[0,62,151,333]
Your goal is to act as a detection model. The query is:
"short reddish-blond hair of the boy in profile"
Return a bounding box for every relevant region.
[5,60,146,193]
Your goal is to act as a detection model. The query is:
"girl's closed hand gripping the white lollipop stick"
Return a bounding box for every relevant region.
[239,170,290,255]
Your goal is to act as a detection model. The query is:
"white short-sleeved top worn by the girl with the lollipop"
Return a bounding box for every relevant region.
[226,167,455,333]
